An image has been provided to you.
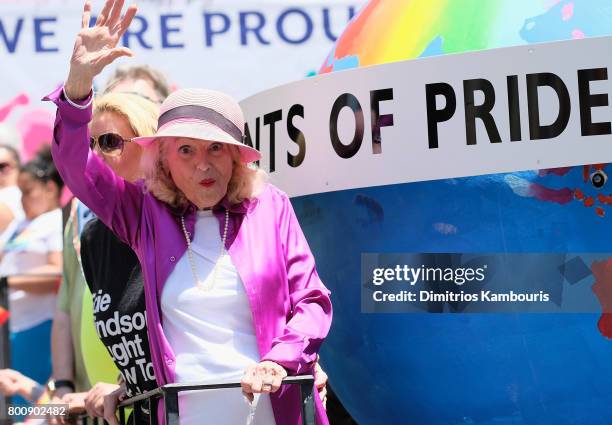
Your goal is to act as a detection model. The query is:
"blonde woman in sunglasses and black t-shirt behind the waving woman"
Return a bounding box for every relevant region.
[58,93,159,423]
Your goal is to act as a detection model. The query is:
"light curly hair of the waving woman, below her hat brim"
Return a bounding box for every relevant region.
[141,139,267,208]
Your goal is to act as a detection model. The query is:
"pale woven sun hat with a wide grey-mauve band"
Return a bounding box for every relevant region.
[132,89,261,163]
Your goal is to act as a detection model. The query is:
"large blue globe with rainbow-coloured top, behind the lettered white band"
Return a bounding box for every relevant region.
[292,0,612,425]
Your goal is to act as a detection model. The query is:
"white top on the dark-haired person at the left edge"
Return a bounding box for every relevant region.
[0,208,62,332]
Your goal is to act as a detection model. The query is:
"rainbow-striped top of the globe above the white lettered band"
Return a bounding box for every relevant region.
[319,0,612,73]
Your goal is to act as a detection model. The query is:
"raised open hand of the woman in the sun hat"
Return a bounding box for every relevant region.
[64,0,137,100]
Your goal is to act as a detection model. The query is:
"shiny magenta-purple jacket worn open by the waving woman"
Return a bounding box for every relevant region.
[43,84,332,425]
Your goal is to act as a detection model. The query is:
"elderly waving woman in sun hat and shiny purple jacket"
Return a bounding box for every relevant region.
[47,0,331,425]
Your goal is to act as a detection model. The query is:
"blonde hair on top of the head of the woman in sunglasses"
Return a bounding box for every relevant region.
[93,93,159,136]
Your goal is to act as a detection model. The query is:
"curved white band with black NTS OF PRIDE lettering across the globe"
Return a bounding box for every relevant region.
[242,37,612,196]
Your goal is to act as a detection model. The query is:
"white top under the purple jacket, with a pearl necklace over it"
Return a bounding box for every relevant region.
[161,211,276,425]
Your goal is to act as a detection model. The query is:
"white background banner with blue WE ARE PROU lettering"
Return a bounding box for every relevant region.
[0,0,365,159]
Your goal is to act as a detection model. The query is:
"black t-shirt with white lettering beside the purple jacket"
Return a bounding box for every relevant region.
[81,218,157,397]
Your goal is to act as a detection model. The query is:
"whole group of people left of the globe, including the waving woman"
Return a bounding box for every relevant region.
[0,0,332,425]
